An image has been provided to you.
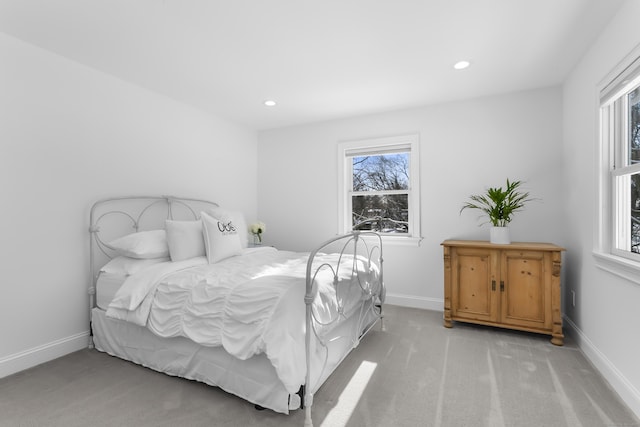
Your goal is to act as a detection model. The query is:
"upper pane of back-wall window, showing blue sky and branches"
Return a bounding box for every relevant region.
[352,153,409,191]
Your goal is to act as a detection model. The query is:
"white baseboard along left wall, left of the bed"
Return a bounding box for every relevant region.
[0,331,89,378]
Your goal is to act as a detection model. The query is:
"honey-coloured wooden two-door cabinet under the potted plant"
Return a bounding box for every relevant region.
[442,240,564,345]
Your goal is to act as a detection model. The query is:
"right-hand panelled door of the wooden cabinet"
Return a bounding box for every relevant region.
[500,251,552,330]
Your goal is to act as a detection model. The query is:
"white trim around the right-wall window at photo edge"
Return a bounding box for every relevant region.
[593,42,640,284]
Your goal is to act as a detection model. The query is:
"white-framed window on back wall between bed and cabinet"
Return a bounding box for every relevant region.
[338,135,420,244]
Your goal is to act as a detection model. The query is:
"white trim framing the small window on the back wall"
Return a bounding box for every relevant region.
[338,134,422,246]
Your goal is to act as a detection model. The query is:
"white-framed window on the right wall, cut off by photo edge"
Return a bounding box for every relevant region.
[600,51,640,267]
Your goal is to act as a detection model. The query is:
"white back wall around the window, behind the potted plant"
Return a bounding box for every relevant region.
[258,87,565,310]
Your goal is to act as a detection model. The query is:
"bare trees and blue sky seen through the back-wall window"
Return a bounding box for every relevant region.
[351,152,410,233]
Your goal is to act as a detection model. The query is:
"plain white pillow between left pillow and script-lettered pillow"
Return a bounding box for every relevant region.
[165,219,205,262]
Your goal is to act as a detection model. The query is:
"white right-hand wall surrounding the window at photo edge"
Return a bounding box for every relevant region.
[563,1,640,415]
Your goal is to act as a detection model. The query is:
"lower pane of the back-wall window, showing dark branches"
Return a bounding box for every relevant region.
[351,194,409,233]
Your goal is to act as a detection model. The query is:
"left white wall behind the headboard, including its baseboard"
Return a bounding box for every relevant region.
[0,33,257,377]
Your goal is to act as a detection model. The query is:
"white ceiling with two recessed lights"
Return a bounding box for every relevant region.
[0,0,623,130]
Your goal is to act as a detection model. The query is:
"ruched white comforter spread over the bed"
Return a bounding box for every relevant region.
[107,248,380,393]
